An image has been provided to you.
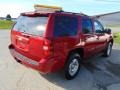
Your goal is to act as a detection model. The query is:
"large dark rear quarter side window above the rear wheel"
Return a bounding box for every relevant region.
[54,16,78,37]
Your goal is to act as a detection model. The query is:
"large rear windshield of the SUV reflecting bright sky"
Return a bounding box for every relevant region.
[13,16,48,36]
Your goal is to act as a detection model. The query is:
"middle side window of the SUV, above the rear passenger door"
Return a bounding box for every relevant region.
[82,18,93,34]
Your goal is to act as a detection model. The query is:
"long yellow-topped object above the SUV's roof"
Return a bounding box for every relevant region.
[34,4,62,13]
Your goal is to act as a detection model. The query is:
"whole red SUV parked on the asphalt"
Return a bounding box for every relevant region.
[9,6,113,79]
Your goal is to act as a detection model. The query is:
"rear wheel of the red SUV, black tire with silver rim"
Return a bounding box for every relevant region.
[64,53,81,80]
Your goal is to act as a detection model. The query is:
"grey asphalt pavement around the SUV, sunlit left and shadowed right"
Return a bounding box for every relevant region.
[0,30,120,90]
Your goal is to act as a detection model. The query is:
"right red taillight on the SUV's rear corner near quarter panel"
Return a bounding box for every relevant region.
[43,40,54,56]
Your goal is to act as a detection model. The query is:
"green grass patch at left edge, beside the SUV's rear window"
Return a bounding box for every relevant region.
[0,20,14,29]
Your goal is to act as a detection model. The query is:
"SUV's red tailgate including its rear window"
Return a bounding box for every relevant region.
[12,16,48,60]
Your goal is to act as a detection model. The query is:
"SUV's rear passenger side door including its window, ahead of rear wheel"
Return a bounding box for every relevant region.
[82,17,98,58]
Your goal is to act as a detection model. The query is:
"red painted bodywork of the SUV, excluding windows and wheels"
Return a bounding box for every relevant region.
[9,13,112,73]
